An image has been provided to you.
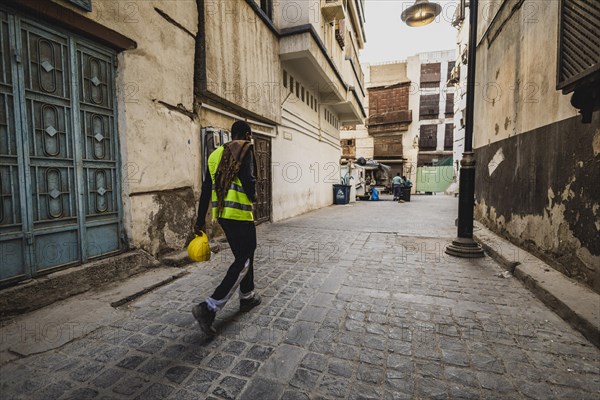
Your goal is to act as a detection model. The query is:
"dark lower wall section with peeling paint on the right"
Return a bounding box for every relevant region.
[475,112,600,292]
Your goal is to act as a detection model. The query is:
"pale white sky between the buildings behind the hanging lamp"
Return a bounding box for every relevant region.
[360,0,457,64]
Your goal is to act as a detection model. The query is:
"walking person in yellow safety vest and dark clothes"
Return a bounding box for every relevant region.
[192,121,261,336]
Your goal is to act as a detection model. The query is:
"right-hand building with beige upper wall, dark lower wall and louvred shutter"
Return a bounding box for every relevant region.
[474,0,600,292]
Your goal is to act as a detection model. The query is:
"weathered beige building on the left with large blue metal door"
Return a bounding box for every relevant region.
[0,0,199,288]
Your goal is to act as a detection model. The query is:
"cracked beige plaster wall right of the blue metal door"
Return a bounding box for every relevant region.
[56,0,200,256]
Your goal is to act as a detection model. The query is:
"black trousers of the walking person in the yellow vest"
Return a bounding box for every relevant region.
[211,218,256,301]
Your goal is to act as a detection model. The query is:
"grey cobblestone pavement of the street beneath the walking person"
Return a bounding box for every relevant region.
[0,196,600,400]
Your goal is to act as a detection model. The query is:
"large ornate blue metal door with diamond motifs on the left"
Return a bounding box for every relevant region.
[0,10,121,281]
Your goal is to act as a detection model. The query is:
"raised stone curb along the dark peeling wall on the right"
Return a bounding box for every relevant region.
[473,221,600,348]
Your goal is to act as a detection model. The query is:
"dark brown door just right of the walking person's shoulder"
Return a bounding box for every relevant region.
[253,134,272,223]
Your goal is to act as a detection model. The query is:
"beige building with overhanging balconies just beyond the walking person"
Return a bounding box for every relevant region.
[199,0,366,221]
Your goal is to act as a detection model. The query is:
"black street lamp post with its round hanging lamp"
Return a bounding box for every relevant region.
[401,0,484,258]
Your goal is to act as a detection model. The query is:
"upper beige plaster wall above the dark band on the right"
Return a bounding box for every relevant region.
[473,0,577,148]
